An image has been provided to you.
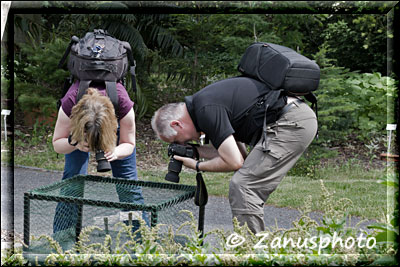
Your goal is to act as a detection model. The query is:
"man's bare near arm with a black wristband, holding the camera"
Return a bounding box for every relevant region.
[174,135,244,172]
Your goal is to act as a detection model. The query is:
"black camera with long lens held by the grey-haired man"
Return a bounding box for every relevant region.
[165,143,199,183]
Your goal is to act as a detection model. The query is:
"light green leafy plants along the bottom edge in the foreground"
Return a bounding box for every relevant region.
[3,181,397,266]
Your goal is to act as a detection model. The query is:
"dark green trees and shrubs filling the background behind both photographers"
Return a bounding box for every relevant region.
[15,11,396,142]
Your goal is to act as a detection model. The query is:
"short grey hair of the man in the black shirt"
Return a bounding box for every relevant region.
[151,102,185,138]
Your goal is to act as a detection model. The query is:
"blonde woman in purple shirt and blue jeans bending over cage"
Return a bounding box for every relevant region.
[53,81,149,232]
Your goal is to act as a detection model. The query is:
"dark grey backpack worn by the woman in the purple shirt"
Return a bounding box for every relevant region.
[58,29,136,119]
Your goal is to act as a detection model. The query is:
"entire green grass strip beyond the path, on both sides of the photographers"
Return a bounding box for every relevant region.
[10,125,387,222]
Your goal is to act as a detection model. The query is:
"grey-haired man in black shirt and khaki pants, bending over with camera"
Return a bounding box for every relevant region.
[151,77,317,233]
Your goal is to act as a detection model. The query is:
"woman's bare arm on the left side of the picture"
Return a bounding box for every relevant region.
[53,108,89,154]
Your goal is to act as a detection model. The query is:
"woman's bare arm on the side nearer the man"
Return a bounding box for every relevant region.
[104,108,136,161]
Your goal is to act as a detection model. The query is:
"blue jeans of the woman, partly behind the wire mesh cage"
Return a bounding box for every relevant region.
[53,148,150,233]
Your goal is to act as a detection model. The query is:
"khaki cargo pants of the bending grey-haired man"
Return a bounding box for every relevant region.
[229,102,317,233]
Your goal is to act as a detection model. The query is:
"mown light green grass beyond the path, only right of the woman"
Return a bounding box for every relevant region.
[139,164,387,219]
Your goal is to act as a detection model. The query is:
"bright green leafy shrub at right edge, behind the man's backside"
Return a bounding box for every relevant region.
[316,67,396,141]
